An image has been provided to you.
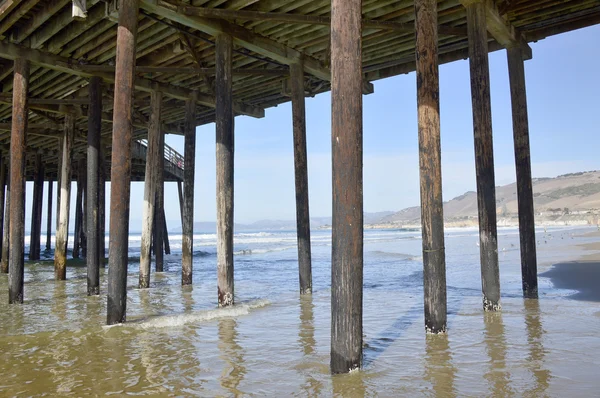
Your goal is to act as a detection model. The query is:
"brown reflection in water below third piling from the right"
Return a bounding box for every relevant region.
[424,334,456,397]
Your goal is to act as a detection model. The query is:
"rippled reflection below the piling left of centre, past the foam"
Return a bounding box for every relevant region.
[219,318,247,397]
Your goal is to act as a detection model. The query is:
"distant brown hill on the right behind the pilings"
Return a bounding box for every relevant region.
[374,171,600,226]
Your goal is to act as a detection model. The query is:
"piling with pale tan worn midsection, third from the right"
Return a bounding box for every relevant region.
[415,0,447,333]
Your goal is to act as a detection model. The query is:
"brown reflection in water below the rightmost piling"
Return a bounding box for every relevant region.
[524,299,552,397]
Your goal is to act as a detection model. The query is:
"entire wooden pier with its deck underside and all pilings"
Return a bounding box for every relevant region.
[0,0,600,373]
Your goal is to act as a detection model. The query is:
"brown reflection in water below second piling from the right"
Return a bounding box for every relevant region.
[483,312,515,397]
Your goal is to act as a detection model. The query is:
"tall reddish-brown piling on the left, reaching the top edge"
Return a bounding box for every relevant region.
[106,0,139,325]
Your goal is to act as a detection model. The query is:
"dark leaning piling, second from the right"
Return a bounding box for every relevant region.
[466,2,500,311]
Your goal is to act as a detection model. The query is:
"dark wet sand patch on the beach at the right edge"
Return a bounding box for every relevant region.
[540,232,600,302]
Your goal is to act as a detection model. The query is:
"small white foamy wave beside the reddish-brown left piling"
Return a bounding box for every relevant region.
[115,299,271,329]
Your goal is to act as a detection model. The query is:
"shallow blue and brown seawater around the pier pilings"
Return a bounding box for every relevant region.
[0,225,600,397]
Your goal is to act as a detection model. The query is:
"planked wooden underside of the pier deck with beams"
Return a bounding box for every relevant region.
[0,0,600,181]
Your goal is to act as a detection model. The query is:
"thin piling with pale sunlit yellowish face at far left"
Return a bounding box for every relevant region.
[54,115,75,280]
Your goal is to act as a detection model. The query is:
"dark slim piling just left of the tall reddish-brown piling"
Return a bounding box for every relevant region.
[86,77,102,296]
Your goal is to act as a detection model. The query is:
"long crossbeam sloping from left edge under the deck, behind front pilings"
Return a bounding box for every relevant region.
[0,41,265,118]
